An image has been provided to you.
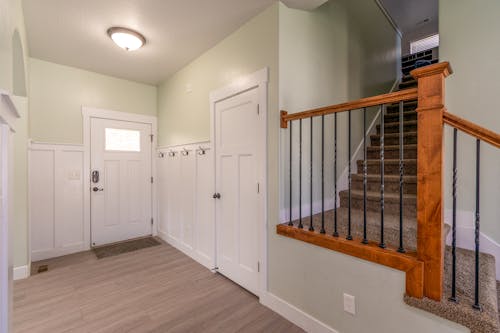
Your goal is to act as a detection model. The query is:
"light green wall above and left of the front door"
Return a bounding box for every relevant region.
[29,58,157,143]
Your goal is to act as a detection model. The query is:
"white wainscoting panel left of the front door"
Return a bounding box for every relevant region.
[29,143,85,261]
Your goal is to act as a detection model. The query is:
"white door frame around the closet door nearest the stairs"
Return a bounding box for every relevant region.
[209,67,269,297]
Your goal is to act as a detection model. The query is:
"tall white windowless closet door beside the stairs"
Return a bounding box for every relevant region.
[215,88,262,295]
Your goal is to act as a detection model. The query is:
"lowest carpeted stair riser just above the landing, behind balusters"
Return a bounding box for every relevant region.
[340,191,417,217]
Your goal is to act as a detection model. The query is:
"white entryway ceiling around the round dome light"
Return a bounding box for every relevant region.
[23,0,278,84]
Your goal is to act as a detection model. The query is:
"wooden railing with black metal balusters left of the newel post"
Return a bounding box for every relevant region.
[277,78,424,298]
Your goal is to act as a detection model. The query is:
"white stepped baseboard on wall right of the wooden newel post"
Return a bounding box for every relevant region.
[444,209,500,281]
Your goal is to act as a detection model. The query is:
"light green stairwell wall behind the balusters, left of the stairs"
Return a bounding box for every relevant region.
[279,0,401,213]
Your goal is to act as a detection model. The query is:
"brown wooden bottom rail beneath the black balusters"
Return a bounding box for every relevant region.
[276,224,424,298]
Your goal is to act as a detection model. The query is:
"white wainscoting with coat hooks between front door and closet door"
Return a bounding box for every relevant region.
[157,142,215,269]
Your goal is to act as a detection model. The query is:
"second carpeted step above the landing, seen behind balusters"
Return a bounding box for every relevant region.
[352,173,417,194]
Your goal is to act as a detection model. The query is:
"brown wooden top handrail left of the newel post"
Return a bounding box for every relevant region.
[281,88,418,128]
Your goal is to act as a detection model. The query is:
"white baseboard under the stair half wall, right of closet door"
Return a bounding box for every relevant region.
[260,292,339,333]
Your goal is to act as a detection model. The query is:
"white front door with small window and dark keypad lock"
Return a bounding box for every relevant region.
[90,118,152,246]
